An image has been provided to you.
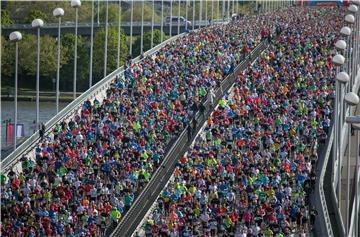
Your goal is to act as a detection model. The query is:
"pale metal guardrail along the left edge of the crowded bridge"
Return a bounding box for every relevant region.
[1,33,185,173]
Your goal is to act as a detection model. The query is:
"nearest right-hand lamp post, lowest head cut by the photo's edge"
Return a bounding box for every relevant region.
[345,116,360,236]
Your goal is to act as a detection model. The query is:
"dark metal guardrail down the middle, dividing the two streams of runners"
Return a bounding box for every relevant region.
[110,41,267,237]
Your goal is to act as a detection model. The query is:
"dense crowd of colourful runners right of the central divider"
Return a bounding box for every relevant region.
[142,8,342,237]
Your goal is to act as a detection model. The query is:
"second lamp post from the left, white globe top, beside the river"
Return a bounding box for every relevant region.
[31,19,44,129]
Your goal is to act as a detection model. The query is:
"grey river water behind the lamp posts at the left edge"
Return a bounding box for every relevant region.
[1,101,67,148]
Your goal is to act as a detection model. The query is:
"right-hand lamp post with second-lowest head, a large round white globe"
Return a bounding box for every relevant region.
[344,92,360,236]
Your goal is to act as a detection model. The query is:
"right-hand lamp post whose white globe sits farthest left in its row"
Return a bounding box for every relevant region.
[332,54,345,205]
